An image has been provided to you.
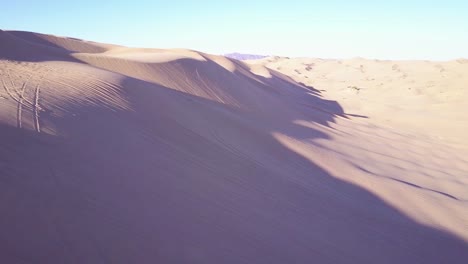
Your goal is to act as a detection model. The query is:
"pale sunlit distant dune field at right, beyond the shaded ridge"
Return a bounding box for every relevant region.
[252,57,468,141]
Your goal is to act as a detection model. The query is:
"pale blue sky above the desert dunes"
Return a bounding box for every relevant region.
[0,0,468,60]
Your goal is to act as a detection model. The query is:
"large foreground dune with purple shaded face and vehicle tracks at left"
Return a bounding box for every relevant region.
[0,31,468,264]
